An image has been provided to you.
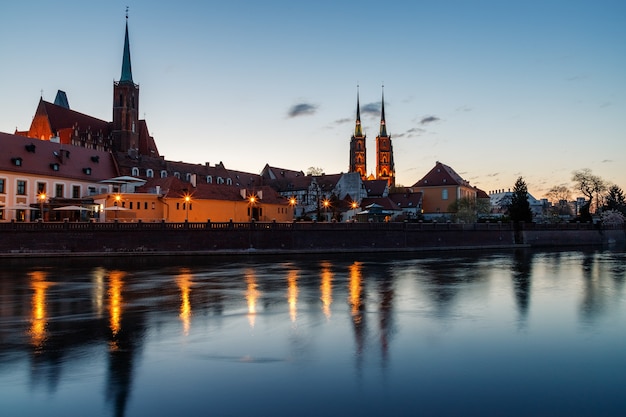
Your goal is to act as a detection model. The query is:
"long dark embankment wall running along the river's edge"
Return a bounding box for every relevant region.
[0,222,626,256]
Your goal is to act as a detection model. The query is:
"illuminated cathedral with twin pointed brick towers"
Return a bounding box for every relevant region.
[348,90,396,187]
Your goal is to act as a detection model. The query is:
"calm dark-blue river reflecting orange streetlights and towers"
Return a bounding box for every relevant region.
[0,249,626,417]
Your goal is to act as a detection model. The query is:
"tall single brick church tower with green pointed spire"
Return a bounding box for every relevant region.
[112,10,139,152]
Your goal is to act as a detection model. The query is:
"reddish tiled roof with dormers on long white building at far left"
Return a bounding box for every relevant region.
[0,132,119,182]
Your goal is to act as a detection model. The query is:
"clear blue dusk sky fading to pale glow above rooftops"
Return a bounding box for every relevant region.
[0,0,626,198]
